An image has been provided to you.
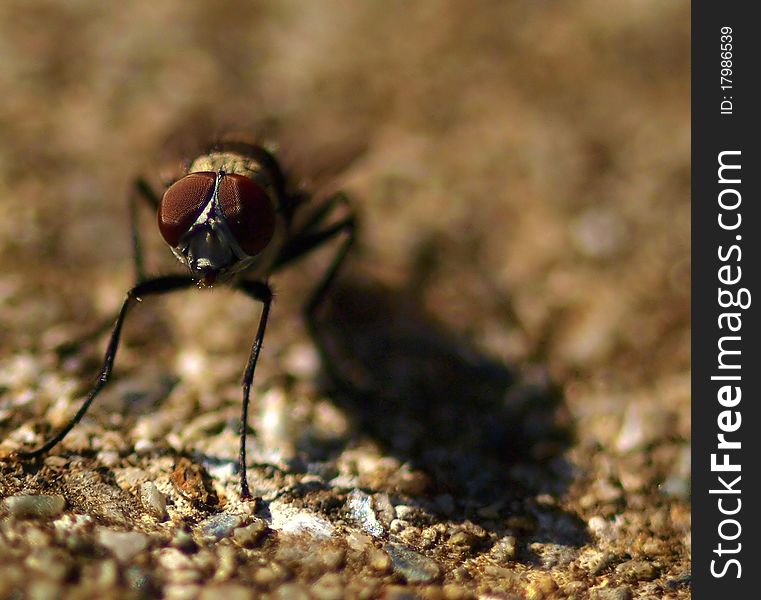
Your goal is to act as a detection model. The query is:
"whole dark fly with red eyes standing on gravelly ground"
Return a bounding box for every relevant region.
[18,141,356,499]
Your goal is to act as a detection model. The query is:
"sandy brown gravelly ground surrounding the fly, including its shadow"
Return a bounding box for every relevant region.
[0,0,690,600]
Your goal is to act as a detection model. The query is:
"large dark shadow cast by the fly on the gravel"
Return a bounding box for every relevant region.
[308,272,584,538]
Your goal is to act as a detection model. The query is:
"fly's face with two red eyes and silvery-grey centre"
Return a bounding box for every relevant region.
[158,169,276,286]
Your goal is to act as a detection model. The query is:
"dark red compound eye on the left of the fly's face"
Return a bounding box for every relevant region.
[158,171,216,246]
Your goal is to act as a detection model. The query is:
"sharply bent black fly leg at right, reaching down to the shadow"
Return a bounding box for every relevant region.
[275,192,357,382]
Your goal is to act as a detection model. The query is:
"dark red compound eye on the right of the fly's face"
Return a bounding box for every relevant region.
[218,175,275,256]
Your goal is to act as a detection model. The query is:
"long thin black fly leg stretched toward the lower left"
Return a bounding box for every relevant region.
[18,275,195,458]
